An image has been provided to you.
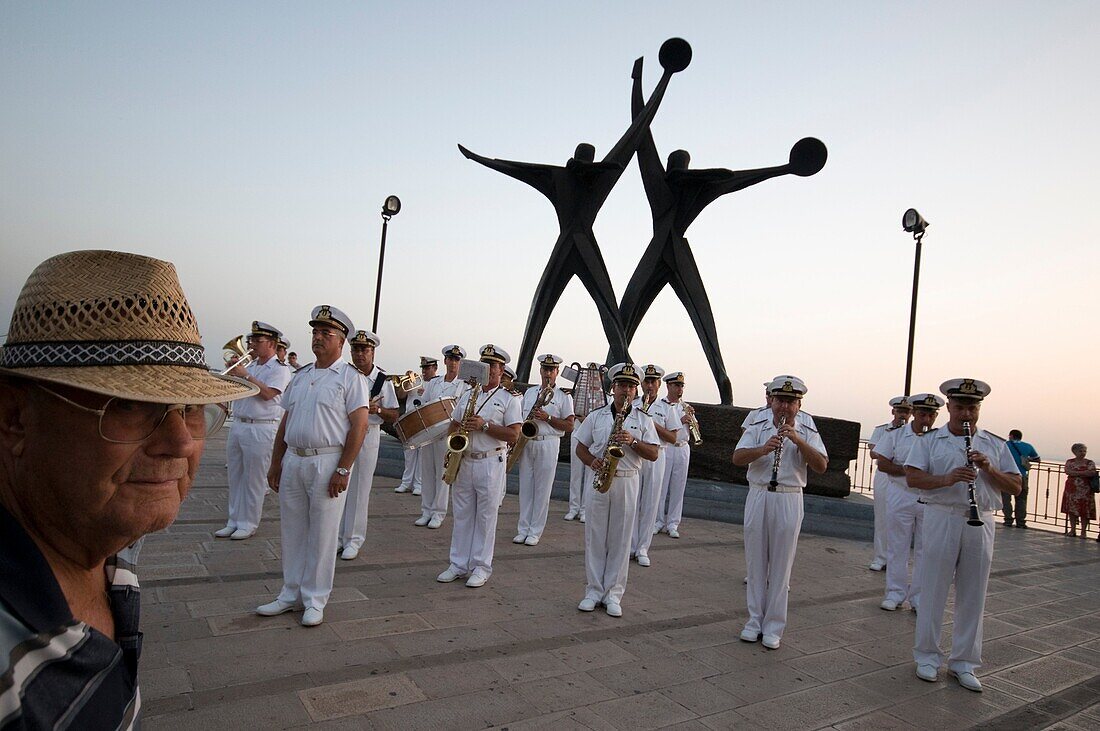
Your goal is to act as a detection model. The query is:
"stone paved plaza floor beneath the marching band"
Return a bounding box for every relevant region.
[141,430,1100,731]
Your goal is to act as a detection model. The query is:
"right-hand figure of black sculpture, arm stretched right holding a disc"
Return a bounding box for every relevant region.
[608,58,827,403]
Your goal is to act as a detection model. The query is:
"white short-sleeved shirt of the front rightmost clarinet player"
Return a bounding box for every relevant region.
[905,427,1020,512]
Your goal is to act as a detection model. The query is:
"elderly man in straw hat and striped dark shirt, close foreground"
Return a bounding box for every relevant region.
[0,251,256,729]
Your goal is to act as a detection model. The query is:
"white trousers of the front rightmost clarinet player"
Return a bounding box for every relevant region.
[913,506,994,673]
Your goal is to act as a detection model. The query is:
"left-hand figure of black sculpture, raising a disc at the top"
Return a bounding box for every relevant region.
[459,38,691,380]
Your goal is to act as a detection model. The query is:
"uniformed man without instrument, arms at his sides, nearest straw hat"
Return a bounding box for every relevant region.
[256,304,370,627]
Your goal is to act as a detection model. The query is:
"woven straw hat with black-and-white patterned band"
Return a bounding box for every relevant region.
[0,251,259,403]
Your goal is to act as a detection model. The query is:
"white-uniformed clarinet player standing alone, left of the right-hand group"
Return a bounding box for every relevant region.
[734,376,828,650]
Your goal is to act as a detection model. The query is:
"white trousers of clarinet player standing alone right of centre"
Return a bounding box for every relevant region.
[745,486,803,638]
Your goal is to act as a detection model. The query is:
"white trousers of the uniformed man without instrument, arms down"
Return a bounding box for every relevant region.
[278,452,345,609]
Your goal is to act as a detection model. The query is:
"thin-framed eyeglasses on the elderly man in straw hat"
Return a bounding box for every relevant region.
[35,384,226,444]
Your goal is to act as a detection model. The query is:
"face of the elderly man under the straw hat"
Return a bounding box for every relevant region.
[0,381,205,566]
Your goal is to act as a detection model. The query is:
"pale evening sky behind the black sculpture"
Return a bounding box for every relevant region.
[0,0,1100,459]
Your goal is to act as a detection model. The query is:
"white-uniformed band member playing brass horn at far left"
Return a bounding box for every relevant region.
[215,320,290,541]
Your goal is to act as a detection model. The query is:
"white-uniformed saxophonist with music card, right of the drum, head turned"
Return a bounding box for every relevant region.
[437,343,524,587]
